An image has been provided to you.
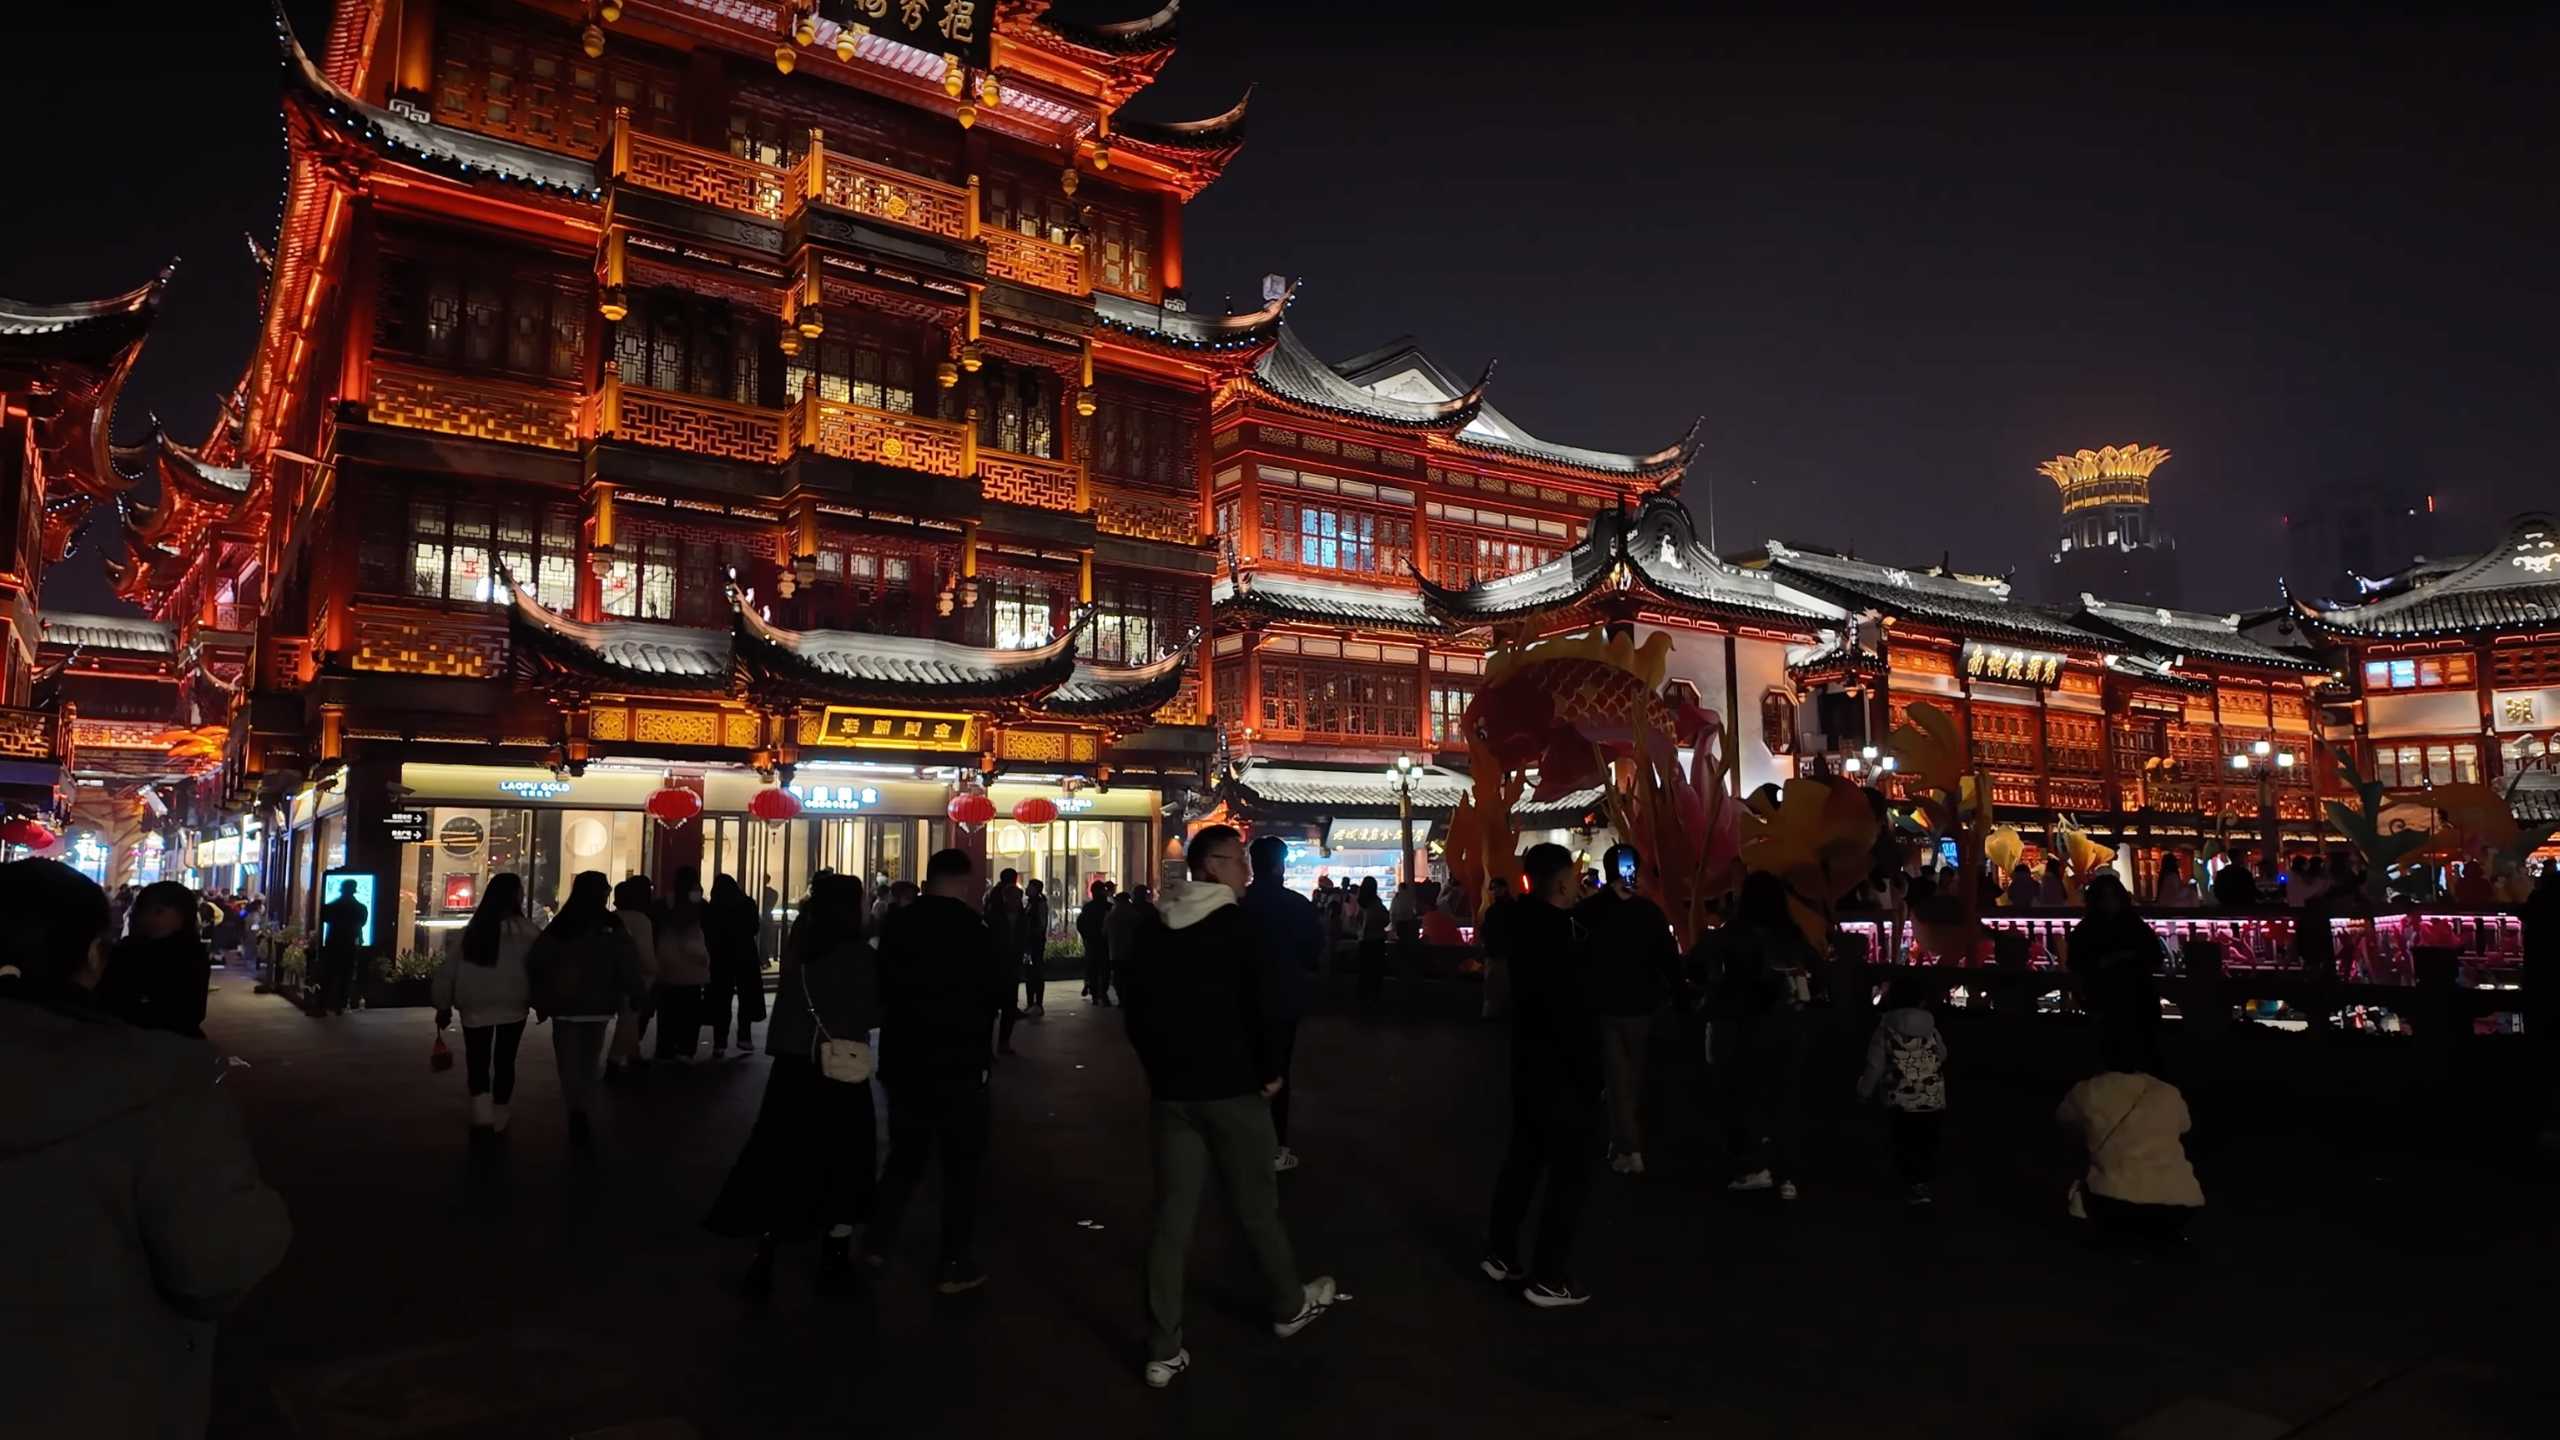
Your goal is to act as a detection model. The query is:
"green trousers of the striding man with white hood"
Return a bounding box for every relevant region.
[1147,1094,1306,1361]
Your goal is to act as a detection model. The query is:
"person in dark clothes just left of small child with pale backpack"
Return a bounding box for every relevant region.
[1708,871,1818,1199]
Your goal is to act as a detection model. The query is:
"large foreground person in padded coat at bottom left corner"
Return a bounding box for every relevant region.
[0,861,292,1440]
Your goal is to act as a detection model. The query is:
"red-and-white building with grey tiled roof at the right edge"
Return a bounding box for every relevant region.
[2284,512,2560,825]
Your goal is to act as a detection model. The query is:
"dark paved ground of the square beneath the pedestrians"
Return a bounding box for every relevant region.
[207,981,2560,1440]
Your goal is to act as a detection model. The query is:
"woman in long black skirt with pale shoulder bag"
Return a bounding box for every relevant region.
[704,876,881,1299]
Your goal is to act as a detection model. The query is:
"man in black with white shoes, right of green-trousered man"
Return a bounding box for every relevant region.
[1482,846,1600,1309]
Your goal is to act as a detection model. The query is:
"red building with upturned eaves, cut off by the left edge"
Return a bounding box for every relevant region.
[0,272,169,817]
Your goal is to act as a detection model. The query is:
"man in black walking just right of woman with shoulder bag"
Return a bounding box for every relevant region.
[863,851,1021,1294]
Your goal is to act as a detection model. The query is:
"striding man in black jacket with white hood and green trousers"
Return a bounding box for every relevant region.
[1121,825,1334,1389]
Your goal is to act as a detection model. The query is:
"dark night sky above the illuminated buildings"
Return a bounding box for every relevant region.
[0,0,2560,607]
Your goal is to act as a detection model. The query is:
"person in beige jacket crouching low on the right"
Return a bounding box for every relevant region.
[2056,1061,2204,1243]
